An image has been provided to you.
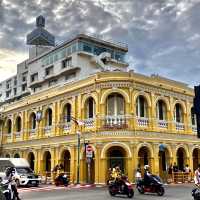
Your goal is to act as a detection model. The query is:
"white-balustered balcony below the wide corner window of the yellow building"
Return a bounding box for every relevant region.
[101,115,128,129]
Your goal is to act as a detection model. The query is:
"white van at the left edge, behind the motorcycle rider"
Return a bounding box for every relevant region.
[0,158,40,186]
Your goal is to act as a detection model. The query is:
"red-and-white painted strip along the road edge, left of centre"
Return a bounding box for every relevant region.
[18,184,95,193]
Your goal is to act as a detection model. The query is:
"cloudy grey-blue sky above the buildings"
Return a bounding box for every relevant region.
[0,0,200,86]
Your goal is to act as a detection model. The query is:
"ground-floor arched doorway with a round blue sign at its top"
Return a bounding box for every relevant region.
[158,144,170,181]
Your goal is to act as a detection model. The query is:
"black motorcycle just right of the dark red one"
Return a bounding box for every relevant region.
[136,175,165,196]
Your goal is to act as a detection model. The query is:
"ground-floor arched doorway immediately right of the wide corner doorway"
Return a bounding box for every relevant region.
[138,146,152,174]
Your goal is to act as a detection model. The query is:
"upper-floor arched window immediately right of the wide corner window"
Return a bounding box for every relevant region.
[136,95,147,117]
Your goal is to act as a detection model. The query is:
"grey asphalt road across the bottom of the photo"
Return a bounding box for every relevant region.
[20,184,193,200]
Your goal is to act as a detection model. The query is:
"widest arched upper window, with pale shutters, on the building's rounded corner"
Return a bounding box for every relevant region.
[107,93,125,116]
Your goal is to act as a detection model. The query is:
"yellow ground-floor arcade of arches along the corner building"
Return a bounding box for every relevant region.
[3,136,200,183]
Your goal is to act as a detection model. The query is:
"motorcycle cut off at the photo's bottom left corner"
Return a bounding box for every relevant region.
[0,181,15,200]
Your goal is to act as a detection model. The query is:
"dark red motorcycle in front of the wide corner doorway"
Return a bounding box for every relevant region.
[108,176,134,198]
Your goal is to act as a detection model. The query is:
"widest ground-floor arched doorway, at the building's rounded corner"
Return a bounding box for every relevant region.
[107,146,127,173]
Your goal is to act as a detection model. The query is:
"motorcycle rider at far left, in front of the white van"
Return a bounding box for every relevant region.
[5,167,21,200]
